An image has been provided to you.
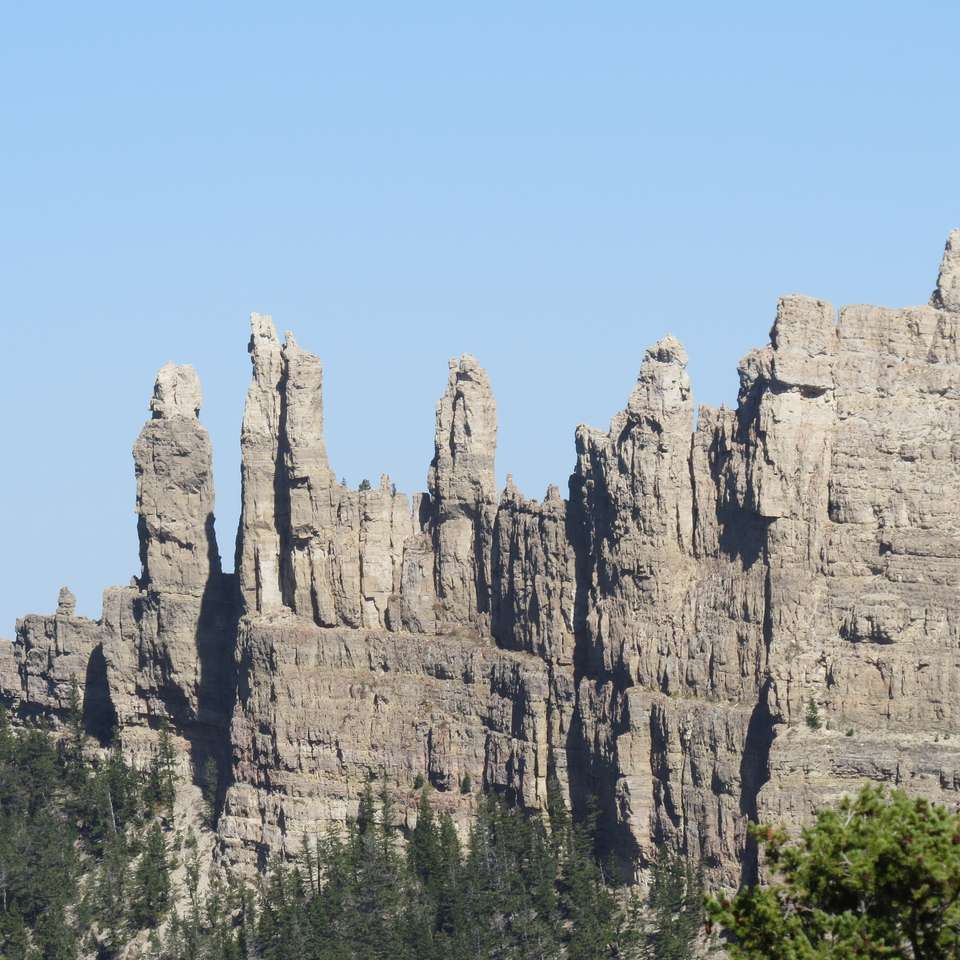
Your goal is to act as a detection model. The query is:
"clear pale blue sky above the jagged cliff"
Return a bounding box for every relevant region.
[0,0,960,637]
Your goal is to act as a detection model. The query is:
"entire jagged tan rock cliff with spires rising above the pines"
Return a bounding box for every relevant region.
[0,232,960,883]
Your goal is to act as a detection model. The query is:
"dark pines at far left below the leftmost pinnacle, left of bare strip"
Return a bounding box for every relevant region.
[0,708,189,960]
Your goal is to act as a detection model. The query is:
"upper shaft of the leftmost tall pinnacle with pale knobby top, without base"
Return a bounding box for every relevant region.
[133,363,220,596]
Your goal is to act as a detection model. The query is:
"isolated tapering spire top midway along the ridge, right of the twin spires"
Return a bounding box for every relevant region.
[428,353,497,504]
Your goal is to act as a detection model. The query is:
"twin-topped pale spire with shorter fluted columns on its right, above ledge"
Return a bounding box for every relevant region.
[237,315,417,628]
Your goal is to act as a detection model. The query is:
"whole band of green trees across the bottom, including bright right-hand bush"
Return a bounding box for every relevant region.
[11,687,960,960]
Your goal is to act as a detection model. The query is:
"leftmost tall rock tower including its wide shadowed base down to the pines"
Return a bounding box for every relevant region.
[97,364,236,765]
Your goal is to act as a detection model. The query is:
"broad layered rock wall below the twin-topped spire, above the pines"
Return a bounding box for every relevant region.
[220,616,549,863]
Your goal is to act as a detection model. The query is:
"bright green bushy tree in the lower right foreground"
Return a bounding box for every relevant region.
[707,787,960,960]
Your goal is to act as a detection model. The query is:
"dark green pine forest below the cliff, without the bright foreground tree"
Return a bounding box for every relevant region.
[0,696,702,960]
